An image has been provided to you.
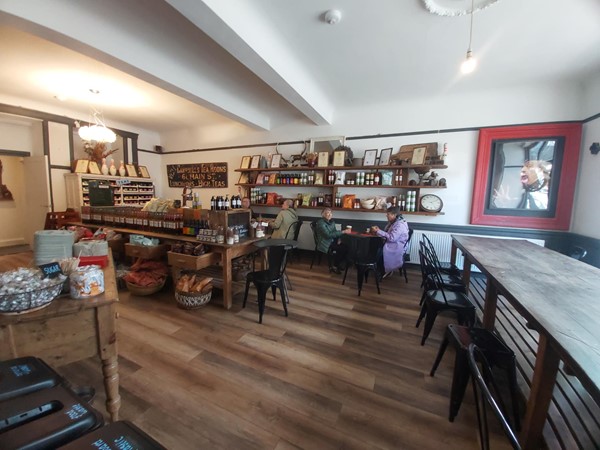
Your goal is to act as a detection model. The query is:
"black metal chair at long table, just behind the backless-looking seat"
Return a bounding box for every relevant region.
[416,249,475,345]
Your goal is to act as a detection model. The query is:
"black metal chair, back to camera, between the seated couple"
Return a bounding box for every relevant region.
[342,234,383,296]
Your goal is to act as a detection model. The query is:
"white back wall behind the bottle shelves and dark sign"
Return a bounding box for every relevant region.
[160,78,600,234]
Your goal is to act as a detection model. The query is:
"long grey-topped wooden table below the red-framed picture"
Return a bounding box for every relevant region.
[452,235,600,449]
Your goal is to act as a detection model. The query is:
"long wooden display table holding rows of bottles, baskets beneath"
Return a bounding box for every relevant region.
[69,222,263,309]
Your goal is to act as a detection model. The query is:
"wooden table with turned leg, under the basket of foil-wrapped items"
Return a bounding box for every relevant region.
[0,256,121,422]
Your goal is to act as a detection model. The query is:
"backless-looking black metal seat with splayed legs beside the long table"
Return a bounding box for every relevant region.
[429,324,520,430]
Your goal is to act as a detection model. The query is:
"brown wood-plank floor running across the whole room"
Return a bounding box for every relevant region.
[0,255,508,450]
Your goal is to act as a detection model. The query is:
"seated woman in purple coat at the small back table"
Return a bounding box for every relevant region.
[371,206,408,278]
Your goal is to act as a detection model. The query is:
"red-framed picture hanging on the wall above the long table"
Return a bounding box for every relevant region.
[471,123,581,230]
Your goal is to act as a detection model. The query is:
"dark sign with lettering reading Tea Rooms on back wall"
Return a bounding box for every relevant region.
[167,163,227,188]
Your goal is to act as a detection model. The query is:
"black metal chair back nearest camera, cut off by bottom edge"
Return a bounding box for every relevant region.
[467,343,521,450]
